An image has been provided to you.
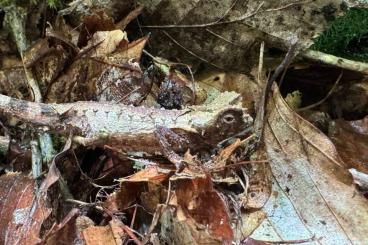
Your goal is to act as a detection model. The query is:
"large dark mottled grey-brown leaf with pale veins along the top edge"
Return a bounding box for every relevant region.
[140,0,346,71]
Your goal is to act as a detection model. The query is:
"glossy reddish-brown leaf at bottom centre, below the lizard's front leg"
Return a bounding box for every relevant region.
[171,176,234,243]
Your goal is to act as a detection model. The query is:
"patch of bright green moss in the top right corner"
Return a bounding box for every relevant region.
[312,8,368,61]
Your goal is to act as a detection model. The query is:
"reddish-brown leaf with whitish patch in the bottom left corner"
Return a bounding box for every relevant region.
[0,173,51,245]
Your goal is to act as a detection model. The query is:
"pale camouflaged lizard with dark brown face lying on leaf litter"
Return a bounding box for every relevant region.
[0,92,253,154]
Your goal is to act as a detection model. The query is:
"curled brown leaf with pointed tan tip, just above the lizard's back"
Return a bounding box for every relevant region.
[46,37,151,105]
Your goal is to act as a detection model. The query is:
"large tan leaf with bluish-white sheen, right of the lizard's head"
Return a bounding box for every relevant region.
[252,86,368,244]
